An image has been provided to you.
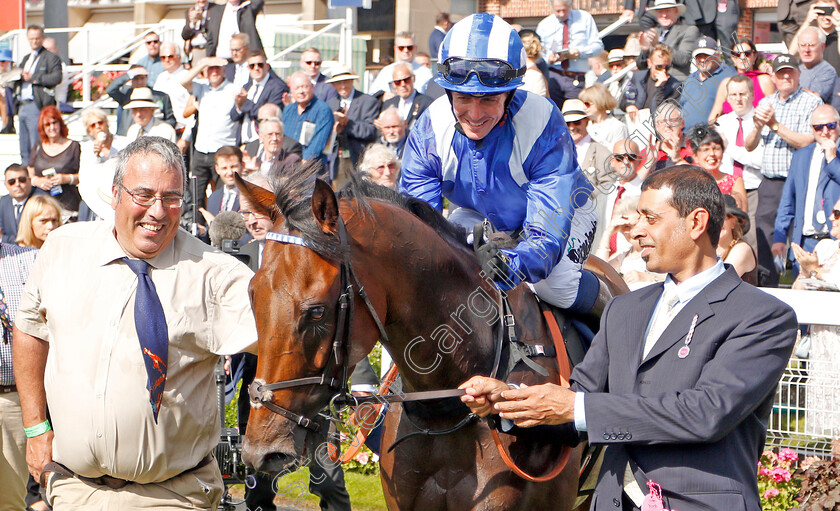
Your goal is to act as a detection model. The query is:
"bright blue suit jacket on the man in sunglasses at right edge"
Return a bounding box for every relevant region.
[773,142,840,255]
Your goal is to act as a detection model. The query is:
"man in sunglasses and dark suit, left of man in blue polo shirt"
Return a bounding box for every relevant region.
[230,50,289,146]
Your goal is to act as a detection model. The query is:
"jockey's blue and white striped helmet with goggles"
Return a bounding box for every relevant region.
[435,13,525,94]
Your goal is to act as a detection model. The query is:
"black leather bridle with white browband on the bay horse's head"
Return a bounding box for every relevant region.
[248,217,388,432]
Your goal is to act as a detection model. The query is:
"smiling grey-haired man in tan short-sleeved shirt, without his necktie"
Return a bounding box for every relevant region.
[14,137,257,510]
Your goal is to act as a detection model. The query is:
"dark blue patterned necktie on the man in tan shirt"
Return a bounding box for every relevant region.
[123,257,169,424]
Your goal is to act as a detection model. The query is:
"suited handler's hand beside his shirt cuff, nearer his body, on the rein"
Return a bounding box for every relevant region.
[493,383,575,428]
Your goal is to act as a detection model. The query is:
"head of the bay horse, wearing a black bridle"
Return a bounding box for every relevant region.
[238,168,377,473]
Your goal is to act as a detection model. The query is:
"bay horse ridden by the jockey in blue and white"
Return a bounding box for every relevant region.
[237,165,620,511]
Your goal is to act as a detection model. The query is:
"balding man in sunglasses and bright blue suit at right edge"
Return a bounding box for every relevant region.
[772,105,840,276]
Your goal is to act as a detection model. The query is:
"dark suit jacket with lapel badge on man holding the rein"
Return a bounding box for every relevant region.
[571,266,797,511]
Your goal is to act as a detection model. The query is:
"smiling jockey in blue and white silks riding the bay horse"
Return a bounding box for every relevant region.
[400,13,607,314]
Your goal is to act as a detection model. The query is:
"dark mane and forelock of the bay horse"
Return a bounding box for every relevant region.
[270,161,466,261]
